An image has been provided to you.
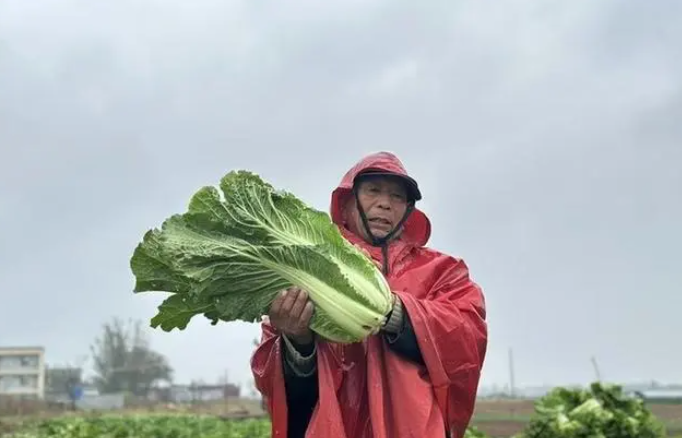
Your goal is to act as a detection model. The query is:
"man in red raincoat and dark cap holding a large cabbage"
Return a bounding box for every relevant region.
[251,152,488,438]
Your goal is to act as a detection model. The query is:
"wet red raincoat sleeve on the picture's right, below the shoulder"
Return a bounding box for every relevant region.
[390,257,488,436]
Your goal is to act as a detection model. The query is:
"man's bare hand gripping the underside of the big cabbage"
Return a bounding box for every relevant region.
[268,287,313,345]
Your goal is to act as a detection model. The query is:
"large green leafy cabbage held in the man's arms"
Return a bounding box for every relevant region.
[130,171,391,342]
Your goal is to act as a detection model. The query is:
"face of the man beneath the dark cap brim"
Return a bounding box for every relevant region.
[345,176,408,242]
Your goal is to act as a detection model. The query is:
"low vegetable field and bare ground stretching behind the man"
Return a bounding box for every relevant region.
[0,400,682,438]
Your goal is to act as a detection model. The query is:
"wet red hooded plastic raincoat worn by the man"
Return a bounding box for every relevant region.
[251,153,487,438]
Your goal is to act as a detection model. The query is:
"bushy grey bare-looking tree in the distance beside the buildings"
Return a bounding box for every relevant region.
[91,318,173,396]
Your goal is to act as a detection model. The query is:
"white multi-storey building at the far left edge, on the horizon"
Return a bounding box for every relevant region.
[0,347,45,399]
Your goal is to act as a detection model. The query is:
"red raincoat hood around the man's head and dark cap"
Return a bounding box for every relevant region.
[330,152,431,246]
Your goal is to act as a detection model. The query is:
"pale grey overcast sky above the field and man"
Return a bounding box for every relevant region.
[0,0,682,385]
